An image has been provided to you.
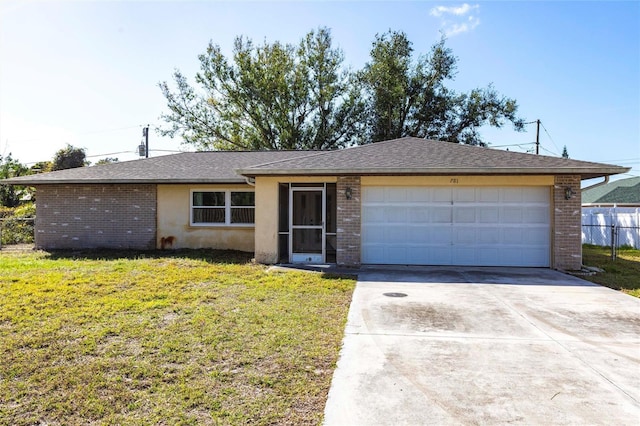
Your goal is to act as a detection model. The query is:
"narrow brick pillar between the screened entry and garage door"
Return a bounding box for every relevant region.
[336,176,361,266]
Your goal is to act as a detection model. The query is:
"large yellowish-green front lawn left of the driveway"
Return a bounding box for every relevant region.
[0,251,354,425]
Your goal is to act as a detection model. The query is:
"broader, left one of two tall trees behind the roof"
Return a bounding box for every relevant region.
[159,28,364,150]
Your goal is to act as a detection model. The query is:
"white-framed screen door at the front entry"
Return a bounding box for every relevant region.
[289,187,325,263]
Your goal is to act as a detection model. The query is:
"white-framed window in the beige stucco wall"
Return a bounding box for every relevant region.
[191,191,256,225]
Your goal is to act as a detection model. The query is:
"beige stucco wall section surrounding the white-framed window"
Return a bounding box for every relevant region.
[156,184,257,252]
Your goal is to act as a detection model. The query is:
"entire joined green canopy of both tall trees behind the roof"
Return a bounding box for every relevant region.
[158,28,523,150]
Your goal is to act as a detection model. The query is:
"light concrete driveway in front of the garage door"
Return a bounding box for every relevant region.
[325,267,640,425]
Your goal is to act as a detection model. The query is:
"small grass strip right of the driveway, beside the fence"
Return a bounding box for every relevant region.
[582,244,640,297]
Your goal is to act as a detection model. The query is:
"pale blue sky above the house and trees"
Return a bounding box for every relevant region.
[0,0,640,183]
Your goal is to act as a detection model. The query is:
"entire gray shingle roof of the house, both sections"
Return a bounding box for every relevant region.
[0,138,629,185]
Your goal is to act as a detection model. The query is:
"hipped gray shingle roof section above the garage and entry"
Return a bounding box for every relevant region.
[238,137,629,179]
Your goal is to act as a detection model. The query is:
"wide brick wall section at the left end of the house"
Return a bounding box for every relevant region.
[35,184,156,249]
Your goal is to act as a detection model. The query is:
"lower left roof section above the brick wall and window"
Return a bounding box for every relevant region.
[0,151,313,185]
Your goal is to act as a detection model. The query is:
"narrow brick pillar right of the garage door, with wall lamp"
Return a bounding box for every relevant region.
[552,175,582,270]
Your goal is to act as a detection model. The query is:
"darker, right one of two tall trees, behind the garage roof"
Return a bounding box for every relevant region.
[360,31,524,145]
